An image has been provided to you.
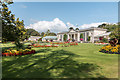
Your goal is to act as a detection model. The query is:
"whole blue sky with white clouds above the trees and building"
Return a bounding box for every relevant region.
[9,2,118,32]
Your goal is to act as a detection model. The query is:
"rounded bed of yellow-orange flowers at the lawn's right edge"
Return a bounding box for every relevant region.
[99,45,120,54]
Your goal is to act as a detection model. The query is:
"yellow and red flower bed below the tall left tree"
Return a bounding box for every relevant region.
[2,49,35,56]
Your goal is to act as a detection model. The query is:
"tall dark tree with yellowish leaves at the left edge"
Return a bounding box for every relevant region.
[0,1,26,47]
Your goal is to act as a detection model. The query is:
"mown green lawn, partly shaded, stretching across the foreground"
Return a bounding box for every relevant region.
[1,43,118,78]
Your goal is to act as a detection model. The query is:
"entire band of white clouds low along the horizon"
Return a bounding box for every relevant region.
[26,18,111,33]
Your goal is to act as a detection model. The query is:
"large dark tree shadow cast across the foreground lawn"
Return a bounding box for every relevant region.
[2,49,109,78]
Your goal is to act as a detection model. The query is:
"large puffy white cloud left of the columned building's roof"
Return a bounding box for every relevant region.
[26,18,68,33]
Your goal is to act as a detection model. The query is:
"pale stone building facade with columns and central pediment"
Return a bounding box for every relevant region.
[57,27,109,43]
